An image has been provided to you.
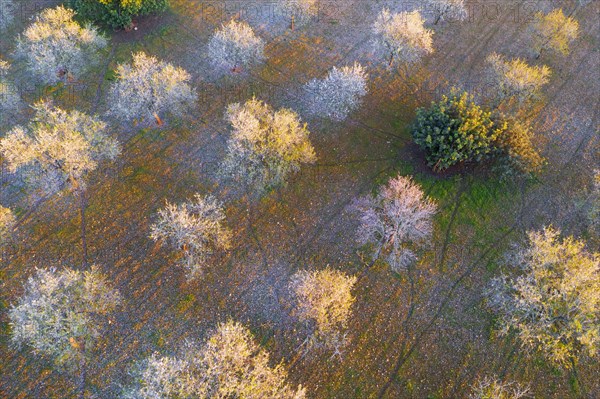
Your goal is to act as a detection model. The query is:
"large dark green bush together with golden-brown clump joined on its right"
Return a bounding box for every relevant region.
[412,90,544,173]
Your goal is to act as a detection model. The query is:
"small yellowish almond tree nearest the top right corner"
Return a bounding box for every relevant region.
[533,8,579,58]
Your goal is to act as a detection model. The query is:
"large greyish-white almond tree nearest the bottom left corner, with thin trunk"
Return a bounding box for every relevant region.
[8,267,121,398]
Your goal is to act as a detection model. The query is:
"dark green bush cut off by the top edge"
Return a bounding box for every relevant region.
[70,0,168,29]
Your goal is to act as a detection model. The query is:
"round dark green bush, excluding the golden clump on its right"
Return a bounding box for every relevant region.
[412,91,506,170]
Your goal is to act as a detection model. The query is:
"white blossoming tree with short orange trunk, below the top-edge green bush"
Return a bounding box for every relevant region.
[109,52,198,125]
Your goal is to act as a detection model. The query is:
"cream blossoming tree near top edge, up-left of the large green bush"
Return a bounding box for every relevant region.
[373,8,433,67]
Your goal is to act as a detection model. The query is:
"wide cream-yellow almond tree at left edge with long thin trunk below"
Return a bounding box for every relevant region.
[0,102,120,265]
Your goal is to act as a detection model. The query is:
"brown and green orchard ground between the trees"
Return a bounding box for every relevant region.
[0,0,600,399]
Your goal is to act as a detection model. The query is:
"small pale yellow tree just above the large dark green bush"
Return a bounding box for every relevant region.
[486,53,550,103]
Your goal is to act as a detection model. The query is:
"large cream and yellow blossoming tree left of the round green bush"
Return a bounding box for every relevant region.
[221,98,316,194]
